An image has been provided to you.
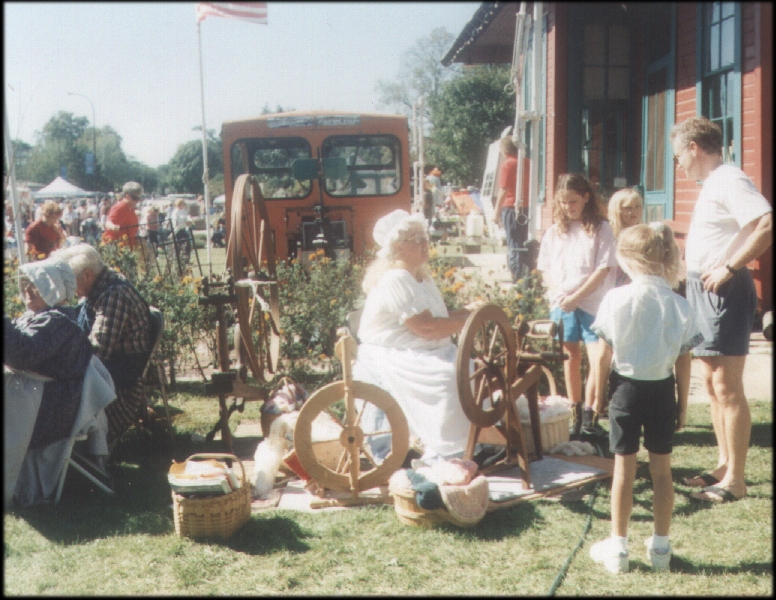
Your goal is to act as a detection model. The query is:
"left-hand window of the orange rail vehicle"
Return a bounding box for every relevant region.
[241,137,312,200]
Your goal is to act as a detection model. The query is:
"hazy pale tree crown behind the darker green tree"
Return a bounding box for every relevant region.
[375,27,461,124]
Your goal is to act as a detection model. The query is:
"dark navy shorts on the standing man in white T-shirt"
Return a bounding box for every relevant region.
[687,268,757,356]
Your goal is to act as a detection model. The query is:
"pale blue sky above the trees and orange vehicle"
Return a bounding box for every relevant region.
[3,2,479,167]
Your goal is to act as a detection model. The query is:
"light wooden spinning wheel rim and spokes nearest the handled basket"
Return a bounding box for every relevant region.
[294,381,409,492]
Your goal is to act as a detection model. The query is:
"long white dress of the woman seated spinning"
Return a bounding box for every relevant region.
[353,269,469,458]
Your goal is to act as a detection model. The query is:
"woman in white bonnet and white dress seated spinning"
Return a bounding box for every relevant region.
[353,210,469,462]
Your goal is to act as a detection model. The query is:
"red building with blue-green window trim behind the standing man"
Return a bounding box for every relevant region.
[442,2,773,311]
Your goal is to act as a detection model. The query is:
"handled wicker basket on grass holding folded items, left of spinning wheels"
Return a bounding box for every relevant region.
[172,454,251,539]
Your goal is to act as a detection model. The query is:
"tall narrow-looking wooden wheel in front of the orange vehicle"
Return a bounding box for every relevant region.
[226,174,280,381]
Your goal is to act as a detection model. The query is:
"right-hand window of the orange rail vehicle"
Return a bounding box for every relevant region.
[321,135,401,196]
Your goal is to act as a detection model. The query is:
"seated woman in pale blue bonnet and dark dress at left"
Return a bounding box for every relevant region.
[3,259,93,449]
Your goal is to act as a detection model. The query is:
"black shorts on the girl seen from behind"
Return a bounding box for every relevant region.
[609,370,677,454]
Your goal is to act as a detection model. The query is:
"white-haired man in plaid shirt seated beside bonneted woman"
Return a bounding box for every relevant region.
[51,244,152,448]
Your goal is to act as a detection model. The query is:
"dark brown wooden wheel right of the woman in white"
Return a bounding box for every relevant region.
[456,304,516,428]
